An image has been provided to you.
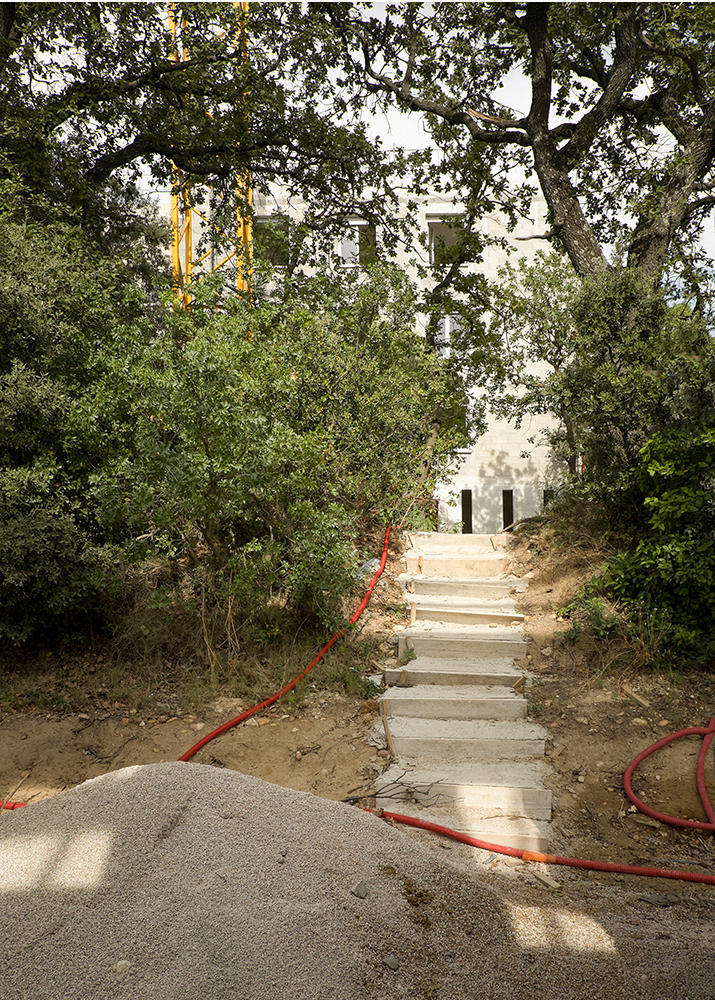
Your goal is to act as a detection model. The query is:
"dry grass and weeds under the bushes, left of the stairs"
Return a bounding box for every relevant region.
[0,548,388,712]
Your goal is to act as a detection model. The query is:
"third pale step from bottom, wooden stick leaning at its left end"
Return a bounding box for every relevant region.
[388,716,546,760]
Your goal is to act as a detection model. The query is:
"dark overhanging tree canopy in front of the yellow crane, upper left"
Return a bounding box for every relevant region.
[0,3,398,252]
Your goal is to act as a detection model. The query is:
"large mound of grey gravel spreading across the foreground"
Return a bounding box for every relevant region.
[0,763,715,1000]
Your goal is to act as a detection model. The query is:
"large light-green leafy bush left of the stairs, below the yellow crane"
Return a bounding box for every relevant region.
[95,272,464,626]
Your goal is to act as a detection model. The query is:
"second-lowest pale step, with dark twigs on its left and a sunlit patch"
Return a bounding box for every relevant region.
[375,761,551,820]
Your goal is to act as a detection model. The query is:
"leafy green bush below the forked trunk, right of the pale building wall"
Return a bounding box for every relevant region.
[493,254,715,480]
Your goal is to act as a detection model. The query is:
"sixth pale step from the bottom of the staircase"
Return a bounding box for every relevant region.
[398,622,527,660]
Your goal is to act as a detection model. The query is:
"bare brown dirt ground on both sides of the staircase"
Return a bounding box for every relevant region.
[0,538,715,892]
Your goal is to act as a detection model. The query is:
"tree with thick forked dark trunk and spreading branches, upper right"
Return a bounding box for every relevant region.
[322,3,715,292]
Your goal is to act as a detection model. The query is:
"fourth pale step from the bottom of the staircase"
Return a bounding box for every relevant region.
[379,684,526,720]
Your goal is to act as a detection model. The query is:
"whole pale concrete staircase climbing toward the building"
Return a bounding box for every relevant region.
[377,532,551,851]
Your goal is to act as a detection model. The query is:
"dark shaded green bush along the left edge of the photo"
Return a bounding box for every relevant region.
[0,219,136,642]
